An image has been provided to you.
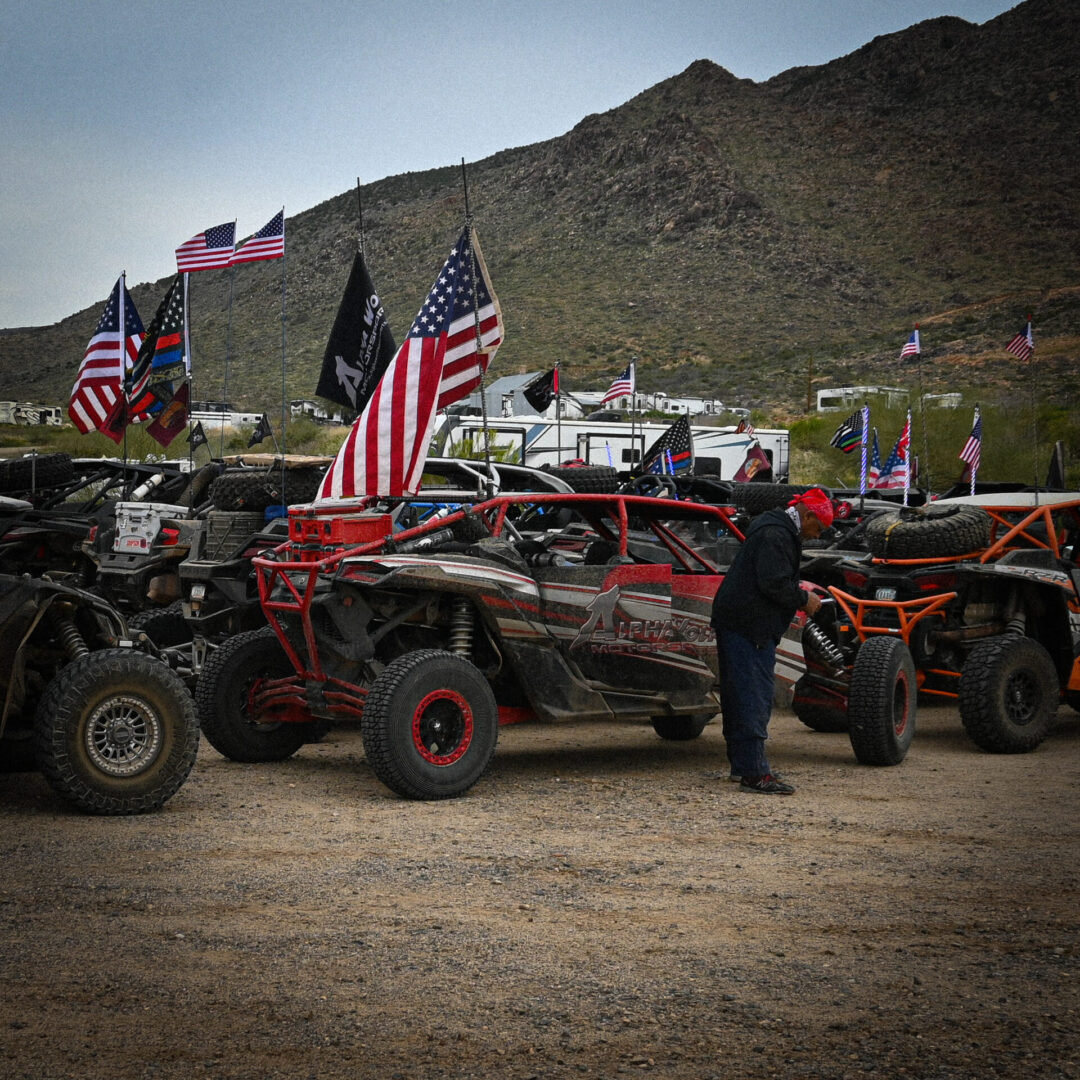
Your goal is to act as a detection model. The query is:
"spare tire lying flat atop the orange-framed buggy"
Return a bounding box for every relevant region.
[866,502,990,558]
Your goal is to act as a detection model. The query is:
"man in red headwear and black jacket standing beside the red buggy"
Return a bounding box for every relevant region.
[712,487,833,795]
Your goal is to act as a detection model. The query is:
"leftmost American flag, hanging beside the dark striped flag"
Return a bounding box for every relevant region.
[68,274,143,443]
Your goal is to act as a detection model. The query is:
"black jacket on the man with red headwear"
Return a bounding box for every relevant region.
[712,509,807,645]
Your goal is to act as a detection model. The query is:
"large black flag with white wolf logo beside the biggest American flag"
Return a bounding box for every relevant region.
[315,252,397,413]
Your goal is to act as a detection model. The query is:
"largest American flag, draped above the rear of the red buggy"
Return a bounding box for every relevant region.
[319,225,503,499]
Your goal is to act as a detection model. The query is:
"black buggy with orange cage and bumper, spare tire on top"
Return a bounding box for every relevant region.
[794,491,1080,753]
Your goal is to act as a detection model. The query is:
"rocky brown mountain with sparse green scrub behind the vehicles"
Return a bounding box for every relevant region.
[0,0,1080,413]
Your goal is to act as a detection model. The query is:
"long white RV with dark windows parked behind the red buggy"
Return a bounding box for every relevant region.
[431,414,789,481]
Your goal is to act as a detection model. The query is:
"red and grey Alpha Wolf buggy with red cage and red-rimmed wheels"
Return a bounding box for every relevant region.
[197,494,914,799]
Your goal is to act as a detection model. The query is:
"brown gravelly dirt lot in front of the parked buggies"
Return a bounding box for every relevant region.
[0,708,1080,1080]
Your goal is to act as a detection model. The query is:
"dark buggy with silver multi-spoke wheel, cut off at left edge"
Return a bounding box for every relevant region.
[0,498,199,814]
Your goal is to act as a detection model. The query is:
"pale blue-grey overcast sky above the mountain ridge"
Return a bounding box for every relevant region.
[0,0,1014,327]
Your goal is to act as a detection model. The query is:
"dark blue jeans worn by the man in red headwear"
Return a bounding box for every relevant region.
[716,630,777,777]
